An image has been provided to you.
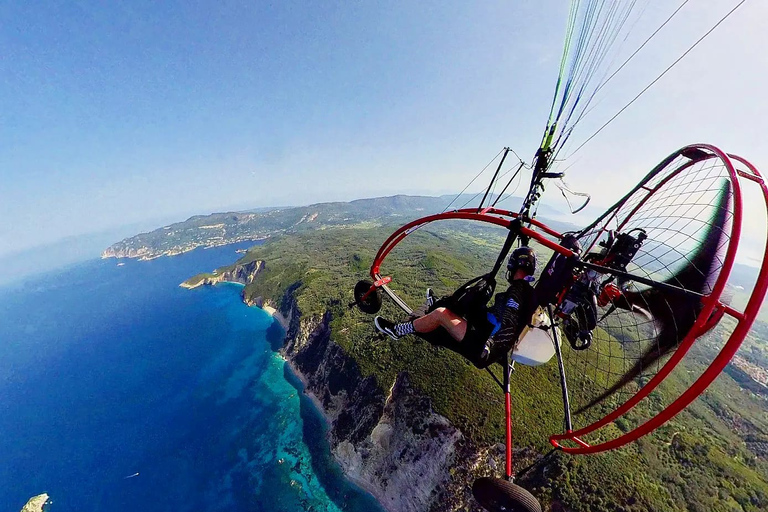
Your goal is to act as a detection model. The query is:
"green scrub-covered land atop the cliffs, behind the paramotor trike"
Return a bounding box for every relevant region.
[194,223,768,512]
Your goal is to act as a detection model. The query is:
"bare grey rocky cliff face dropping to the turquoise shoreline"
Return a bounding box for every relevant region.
[270,292,516,512]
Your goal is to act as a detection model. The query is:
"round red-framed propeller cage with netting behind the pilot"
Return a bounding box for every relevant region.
[550,144,768,453]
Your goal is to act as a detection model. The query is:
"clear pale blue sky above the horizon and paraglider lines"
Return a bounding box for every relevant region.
[0,0,768,256]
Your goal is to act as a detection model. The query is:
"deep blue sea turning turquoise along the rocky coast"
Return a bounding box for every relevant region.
[0,243,382,512]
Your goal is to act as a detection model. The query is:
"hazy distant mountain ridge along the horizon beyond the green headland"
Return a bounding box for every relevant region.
[102,194,574,259]
